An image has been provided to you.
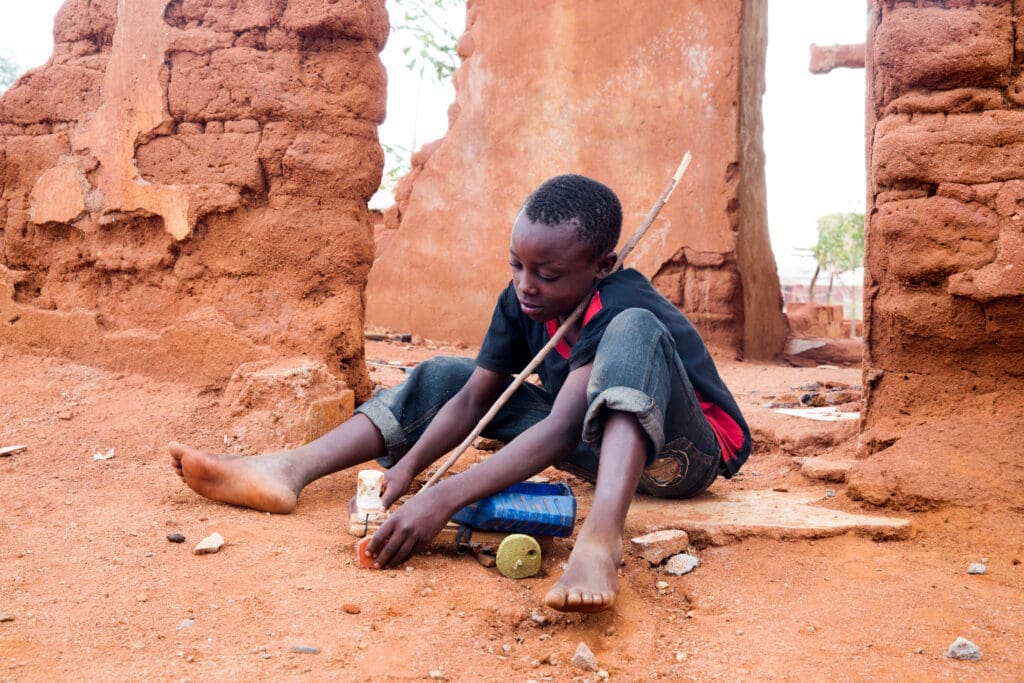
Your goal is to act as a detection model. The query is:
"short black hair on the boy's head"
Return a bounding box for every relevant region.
[522,173,623,258]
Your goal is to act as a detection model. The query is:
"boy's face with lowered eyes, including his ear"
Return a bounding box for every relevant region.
[509,213,615,323]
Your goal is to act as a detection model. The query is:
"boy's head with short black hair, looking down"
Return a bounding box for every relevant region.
[509,175,623,323]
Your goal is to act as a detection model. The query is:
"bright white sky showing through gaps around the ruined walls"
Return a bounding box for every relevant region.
[0,0,867,278]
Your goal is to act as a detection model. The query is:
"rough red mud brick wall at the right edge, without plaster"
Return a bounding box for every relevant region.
[864,0,1024,454]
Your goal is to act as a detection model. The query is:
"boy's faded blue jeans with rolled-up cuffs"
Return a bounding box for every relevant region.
[356,308,721,498]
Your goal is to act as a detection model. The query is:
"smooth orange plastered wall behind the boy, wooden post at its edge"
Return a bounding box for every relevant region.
[368,0,785,356]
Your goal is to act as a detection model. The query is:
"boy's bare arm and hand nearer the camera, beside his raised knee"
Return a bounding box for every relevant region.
[367,365,591,567]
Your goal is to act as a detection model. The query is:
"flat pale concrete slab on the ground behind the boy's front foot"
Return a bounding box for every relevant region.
[627,488,910,546]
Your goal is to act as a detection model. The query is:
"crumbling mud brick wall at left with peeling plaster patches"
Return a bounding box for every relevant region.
[0,0,388,397]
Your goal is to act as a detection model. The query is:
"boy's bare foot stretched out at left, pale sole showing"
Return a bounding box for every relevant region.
[168,441,302,514]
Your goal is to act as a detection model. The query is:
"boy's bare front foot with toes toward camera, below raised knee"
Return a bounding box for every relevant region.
[544,541,623,612]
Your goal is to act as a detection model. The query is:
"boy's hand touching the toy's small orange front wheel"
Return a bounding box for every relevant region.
[367,486,454,568]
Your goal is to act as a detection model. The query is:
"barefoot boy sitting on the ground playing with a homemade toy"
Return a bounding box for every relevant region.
[165,175,751,611]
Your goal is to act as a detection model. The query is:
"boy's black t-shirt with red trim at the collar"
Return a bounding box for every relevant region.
[476,268,751,475]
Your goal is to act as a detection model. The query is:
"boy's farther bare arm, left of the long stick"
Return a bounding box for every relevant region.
[382,367,508,508]
